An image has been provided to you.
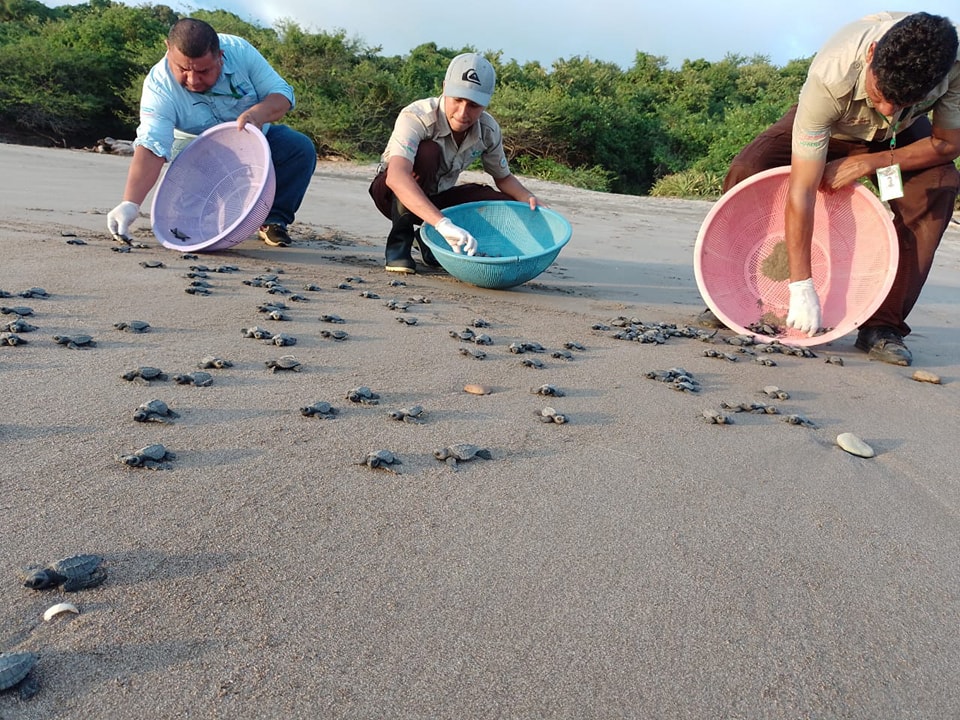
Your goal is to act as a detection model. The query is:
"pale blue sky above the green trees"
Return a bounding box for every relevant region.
[44,0,960,68]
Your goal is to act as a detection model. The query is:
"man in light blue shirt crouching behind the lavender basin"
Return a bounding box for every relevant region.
[107,18,317,247]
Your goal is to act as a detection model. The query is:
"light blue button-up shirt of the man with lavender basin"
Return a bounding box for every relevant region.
[133,34,294,160]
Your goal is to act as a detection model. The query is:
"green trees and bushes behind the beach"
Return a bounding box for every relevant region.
[0,0,809,198]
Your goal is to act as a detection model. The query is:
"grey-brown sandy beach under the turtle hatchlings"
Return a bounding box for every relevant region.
[0,144,960,720]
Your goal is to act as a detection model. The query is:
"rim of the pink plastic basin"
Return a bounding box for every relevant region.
[693,165,900,346]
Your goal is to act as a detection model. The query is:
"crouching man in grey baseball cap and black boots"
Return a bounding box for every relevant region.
[370,53,539,273]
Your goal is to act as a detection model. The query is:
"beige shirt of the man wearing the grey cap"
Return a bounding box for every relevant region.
[382,97,510,195]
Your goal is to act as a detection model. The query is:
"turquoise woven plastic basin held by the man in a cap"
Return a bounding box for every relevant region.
[420,201,573,289]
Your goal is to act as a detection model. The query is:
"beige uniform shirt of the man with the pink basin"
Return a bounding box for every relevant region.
[792,12,960,160]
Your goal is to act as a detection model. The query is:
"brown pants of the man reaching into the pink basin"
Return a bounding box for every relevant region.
[723,106,960,335]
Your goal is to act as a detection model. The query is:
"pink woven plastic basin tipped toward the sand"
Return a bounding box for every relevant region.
[694,167,899,346]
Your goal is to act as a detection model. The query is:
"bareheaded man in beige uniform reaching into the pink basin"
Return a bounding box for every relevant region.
[723,12,960,365]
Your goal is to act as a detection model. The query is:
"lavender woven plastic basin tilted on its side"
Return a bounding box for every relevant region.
[150,122,276,252]
